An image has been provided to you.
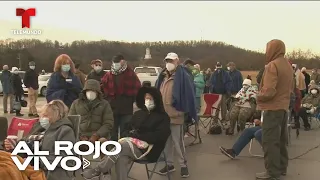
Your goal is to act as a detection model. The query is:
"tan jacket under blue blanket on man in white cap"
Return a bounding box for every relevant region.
[160,74,184,124]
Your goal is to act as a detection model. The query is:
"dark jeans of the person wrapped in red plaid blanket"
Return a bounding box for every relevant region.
[111,114,132,141]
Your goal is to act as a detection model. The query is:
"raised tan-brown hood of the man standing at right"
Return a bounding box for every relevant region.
[266,39,286,63]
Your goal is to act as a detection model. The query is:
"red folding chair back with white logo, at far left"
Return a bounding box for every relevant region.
[8,117,39,139]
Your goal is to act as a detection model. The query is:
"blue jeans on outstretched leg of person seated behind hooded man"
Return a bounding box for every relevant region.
[232,126,262,156]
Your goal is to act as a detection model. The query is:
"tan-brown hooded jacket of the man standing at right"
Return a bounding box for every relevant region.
[257,40,294,110]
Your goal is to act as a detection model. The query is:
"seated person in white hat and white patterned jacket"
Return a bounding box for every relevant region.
[226,79,257,135]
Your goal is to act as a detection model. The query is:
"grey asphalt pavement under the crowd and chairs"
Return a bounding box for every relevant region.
[0,97,320,180]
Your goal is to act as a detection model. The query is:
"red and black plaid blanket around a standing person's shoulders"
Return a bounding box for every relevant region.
[101,67,141,98]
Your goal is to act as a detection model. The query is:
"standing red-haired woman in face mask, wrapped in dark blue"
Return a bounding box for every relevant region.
[46,54,82,107]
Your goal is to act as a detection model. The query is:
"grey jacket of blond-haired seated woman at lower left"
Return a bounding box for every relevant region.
[40,118,76,180]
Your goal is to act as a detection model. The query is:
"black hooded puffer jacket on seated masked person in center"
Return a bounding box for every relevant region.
[122,87,171,162]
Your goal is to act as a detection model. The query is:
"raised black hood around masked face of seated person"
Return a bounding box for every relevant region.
[136,87,165,112]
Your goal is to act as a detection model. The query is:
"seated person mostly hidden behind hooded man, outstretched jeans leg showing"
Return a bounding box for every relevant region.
[219,110,262,159]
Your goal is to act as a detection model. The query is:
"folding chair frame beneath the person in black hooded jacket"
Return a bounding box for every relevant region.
[128,152,171,180]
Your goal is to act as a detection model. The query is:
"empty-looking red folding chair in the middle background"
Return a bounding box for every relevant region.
[198,94,222,133]
